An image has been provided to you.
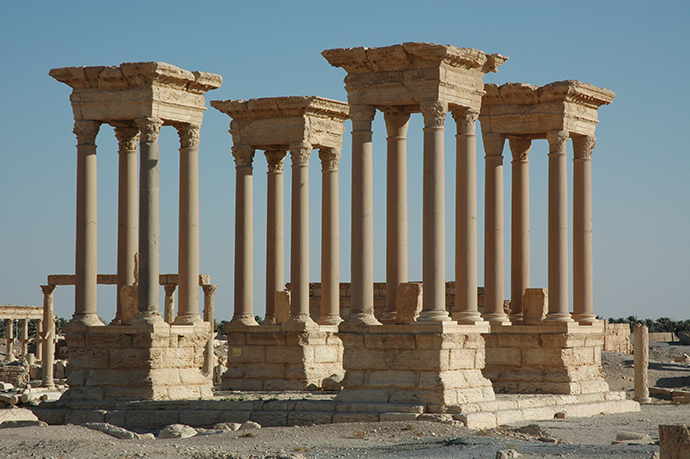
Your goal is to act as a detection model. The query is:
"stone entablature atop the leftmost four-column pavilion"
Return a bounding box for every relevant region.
[49,62,223,126]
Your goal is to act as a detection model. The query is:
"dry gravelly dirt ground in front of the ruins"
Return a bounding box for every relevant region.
[0,343,690,459]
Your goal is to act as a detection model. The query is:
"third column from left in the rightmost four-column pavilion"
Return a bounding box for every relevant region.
[545,131,573,322]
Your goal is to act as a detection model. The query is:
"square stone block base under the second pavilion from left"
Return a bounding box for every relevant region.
[221,324,343,390]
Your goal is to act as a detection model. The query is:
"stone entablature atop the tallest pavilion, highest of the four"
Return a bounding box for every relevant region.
[321,43,508,113]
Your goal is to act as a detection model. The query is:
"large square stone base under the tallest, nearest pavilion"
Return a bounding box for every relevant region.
[337,322,494,411]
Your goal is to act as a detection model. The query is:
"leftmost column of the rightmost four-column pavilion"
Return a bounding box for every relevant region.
[482,133,509,325]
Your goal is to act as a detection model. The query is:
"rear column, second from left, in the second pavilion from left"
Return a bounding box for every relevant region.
[261,150,286,325]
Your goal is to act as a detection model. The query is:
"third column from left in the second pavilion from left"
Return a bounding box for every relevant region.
[284,142,316,328]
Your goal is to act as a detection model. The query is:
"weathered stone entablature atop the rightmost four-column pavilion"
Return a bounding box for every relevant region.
[479,80,616,139]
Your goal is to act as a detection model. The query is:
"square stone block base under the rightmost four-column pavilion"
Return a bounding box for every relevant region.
[484,323,609,395]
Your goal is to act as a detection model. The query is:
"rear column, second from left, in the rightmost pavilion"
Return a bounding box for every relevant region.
[509,138,532,323]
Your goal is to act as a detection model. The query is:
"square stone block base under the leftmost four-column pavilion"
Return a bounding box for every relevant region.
[62,320,212,400]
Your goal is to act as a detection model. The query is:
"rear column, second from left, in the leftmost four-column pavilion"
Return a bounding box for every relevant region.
[113,126,139,324]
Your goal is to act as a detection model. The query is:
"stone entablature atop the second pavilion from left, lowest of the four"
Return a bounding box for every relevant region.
[211,96,349,151]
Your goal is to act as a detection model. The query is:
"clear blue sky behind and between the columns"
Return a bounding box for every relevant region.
[0,0,690,320]
